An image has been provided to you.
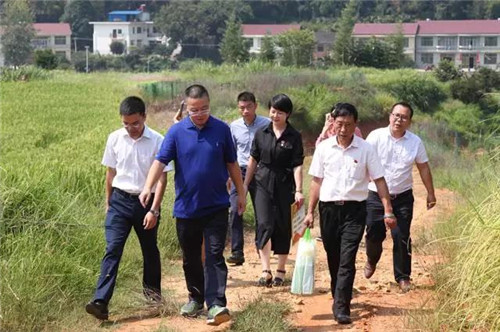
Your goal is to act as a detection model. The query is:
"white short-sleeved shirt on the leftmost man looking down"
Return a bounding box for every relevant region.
[102,126,173,194]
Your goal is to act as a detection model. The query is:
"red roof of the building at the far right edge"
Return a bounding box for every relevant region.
[417,20,500,35]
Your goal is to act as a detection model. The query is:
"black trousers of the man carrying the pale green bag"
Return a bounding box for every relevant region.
[319,201,366,315]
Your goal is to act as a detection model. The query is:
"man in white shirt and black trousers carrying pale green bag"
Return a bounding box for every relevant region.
[304,103,396,324]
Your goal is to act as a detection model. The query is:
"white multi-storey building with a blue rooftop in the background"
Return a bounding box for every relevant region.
[89,7,162,55]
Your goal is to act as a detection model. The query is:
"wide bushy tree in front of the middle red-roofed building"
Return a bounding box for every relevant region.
[276,30,316,66]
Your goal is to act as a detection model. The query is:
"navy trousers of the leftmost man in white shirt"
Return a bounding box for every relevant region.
[94,188,161,303]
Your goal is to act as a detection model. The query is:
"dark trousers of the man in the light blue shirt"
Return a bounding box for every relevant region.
[229,167,257,256]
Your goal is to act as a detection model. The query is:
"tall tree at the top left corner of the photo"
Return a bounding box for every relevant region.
[1,0,35,66]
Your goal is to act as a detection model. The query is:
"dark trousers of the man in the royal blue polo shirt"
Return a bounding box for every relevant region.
[176,209,228,308]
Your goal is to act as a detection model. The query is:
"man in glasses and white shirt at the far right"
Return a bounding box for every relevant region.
[364,102,436,293]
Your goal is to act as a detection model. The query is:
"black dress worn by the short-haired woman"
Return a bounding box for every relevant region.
[250,123,304,254]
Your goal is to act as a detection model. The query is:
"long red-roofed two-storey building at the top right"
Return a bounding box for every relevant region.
[353,20,500,69]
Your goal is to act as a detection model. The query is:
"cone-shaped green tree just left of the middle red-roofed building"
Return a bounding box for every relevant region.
[220,16,249,63]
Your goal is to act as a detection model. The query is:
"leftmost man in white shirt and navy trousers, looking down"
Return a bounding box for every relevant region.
[85,97,172,320]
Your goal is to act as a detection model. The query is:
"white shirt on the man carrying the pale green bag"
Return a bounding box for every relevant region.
[309,136,384,202]
